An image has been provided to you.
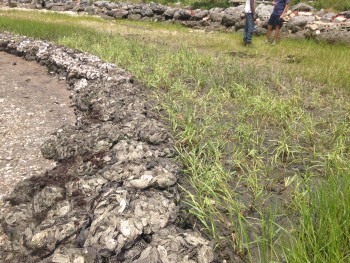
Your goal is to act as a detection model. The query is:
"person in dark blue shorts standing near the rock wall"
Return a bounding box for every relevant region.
[265,0,289,45]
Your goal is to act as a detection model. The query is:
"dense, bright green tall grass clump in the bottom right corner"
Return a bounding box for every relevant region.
[285,168,350,263]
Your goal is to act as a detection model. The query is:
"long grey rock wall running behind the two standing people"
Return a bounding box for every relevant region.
[4,0,350,44]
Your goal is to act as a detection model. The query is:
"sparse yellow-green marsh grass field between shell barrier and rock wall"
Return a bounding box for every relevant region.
[0,9,350,262]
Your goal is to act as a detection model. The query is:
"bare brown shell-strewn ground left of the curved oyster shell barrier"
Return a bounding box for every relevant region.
[0,52,75,200]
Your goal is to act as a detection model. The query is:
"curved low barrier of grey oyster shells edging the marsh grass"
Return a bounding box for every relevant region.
[0,33,213,263]
